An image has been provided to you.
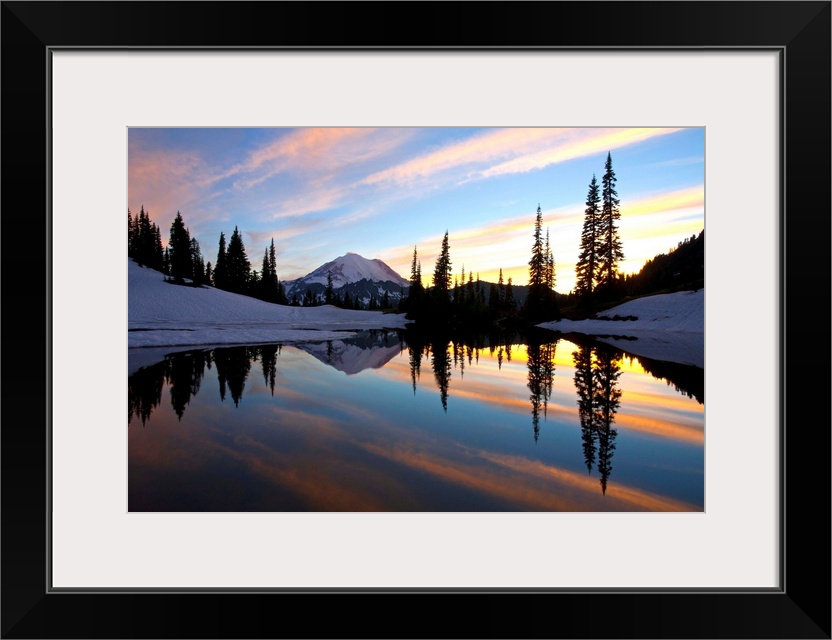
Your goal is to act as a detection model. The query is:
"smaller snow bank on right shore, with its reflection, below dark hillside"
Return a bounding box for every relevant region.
[538,289,705,368]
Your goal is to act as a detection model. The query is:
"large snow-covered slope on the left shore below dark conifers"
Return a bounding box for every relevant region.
[127,260,405,347]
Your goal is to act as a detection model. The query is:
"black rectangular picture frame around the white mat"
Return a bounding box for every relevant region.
[0,1,832,638]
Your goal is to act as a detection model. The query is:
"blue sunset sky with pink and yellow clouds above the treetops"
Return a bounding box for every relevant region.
[128,127,705,293]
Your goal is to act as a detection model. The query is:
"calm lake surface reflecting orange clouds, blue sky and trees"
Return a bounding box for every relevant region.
[128,332,704,511]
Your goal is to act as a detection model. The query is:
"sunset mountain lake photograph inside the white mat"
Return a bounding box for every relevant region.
[123,124,704,518]
